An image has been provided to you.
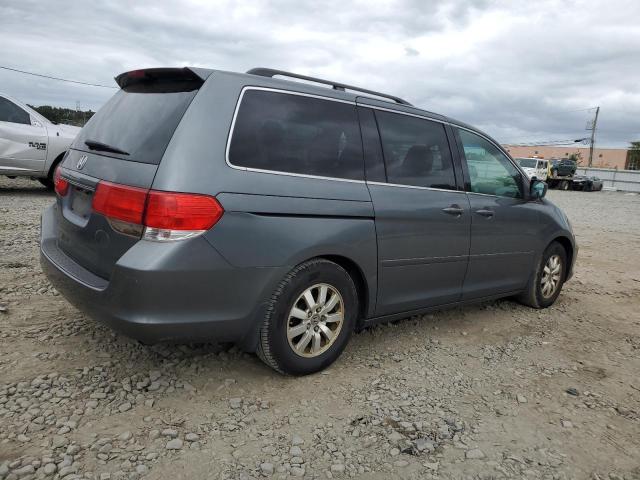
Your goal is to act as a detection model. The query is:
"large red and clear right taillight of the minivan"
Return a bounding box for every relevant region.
[93,182,224,241]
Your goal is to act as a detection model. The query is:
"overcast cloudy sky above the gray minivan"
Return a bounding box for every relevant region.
[0,0,640,147]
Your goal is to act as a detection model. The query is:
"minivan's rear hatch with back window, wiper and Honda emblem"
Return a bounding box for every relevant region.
[56,68,206,279]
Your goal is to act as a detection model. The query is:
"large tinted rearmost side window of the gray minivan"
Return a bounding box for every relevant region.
[228,90,364,180]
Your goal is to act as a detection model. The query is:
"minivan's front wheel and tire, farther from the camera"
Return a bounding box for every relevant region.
[516,242,567,308]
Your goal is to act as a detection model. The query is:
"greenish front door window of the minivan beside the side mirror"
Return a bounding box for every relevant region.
[457,129,522,198]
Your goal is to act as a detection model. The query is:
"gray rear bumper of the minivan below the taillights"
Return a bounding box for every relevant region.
[40,205,286,349]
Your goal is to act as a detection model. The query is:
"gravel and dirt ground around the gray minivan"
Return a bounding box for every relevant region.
[0,177,640,480]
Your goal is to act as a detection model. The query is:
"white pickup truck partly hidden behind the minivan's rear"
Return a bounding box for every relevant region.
[0,94,80,188]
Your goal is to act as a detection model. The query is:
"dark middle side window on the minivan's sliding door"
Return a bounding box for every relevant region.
[376,111,456,190]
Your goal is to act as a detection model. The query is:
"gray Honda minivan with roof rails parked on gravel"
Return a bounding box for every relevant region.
[41,68,577,374]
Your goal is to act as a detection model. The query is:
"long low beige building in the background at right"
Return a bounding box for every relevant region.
[503,145,634,170]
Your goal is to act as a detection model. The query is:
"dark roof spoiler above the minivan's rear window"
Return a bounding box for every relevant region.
[115,67,211,91]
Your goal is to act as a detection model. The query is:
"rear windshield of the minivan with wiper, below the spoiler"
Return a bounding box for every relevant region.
[73,89,197,165]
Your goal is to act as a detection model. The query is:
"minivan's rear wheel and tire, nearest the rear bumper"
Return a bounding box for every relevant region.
[257,258,359,375]
